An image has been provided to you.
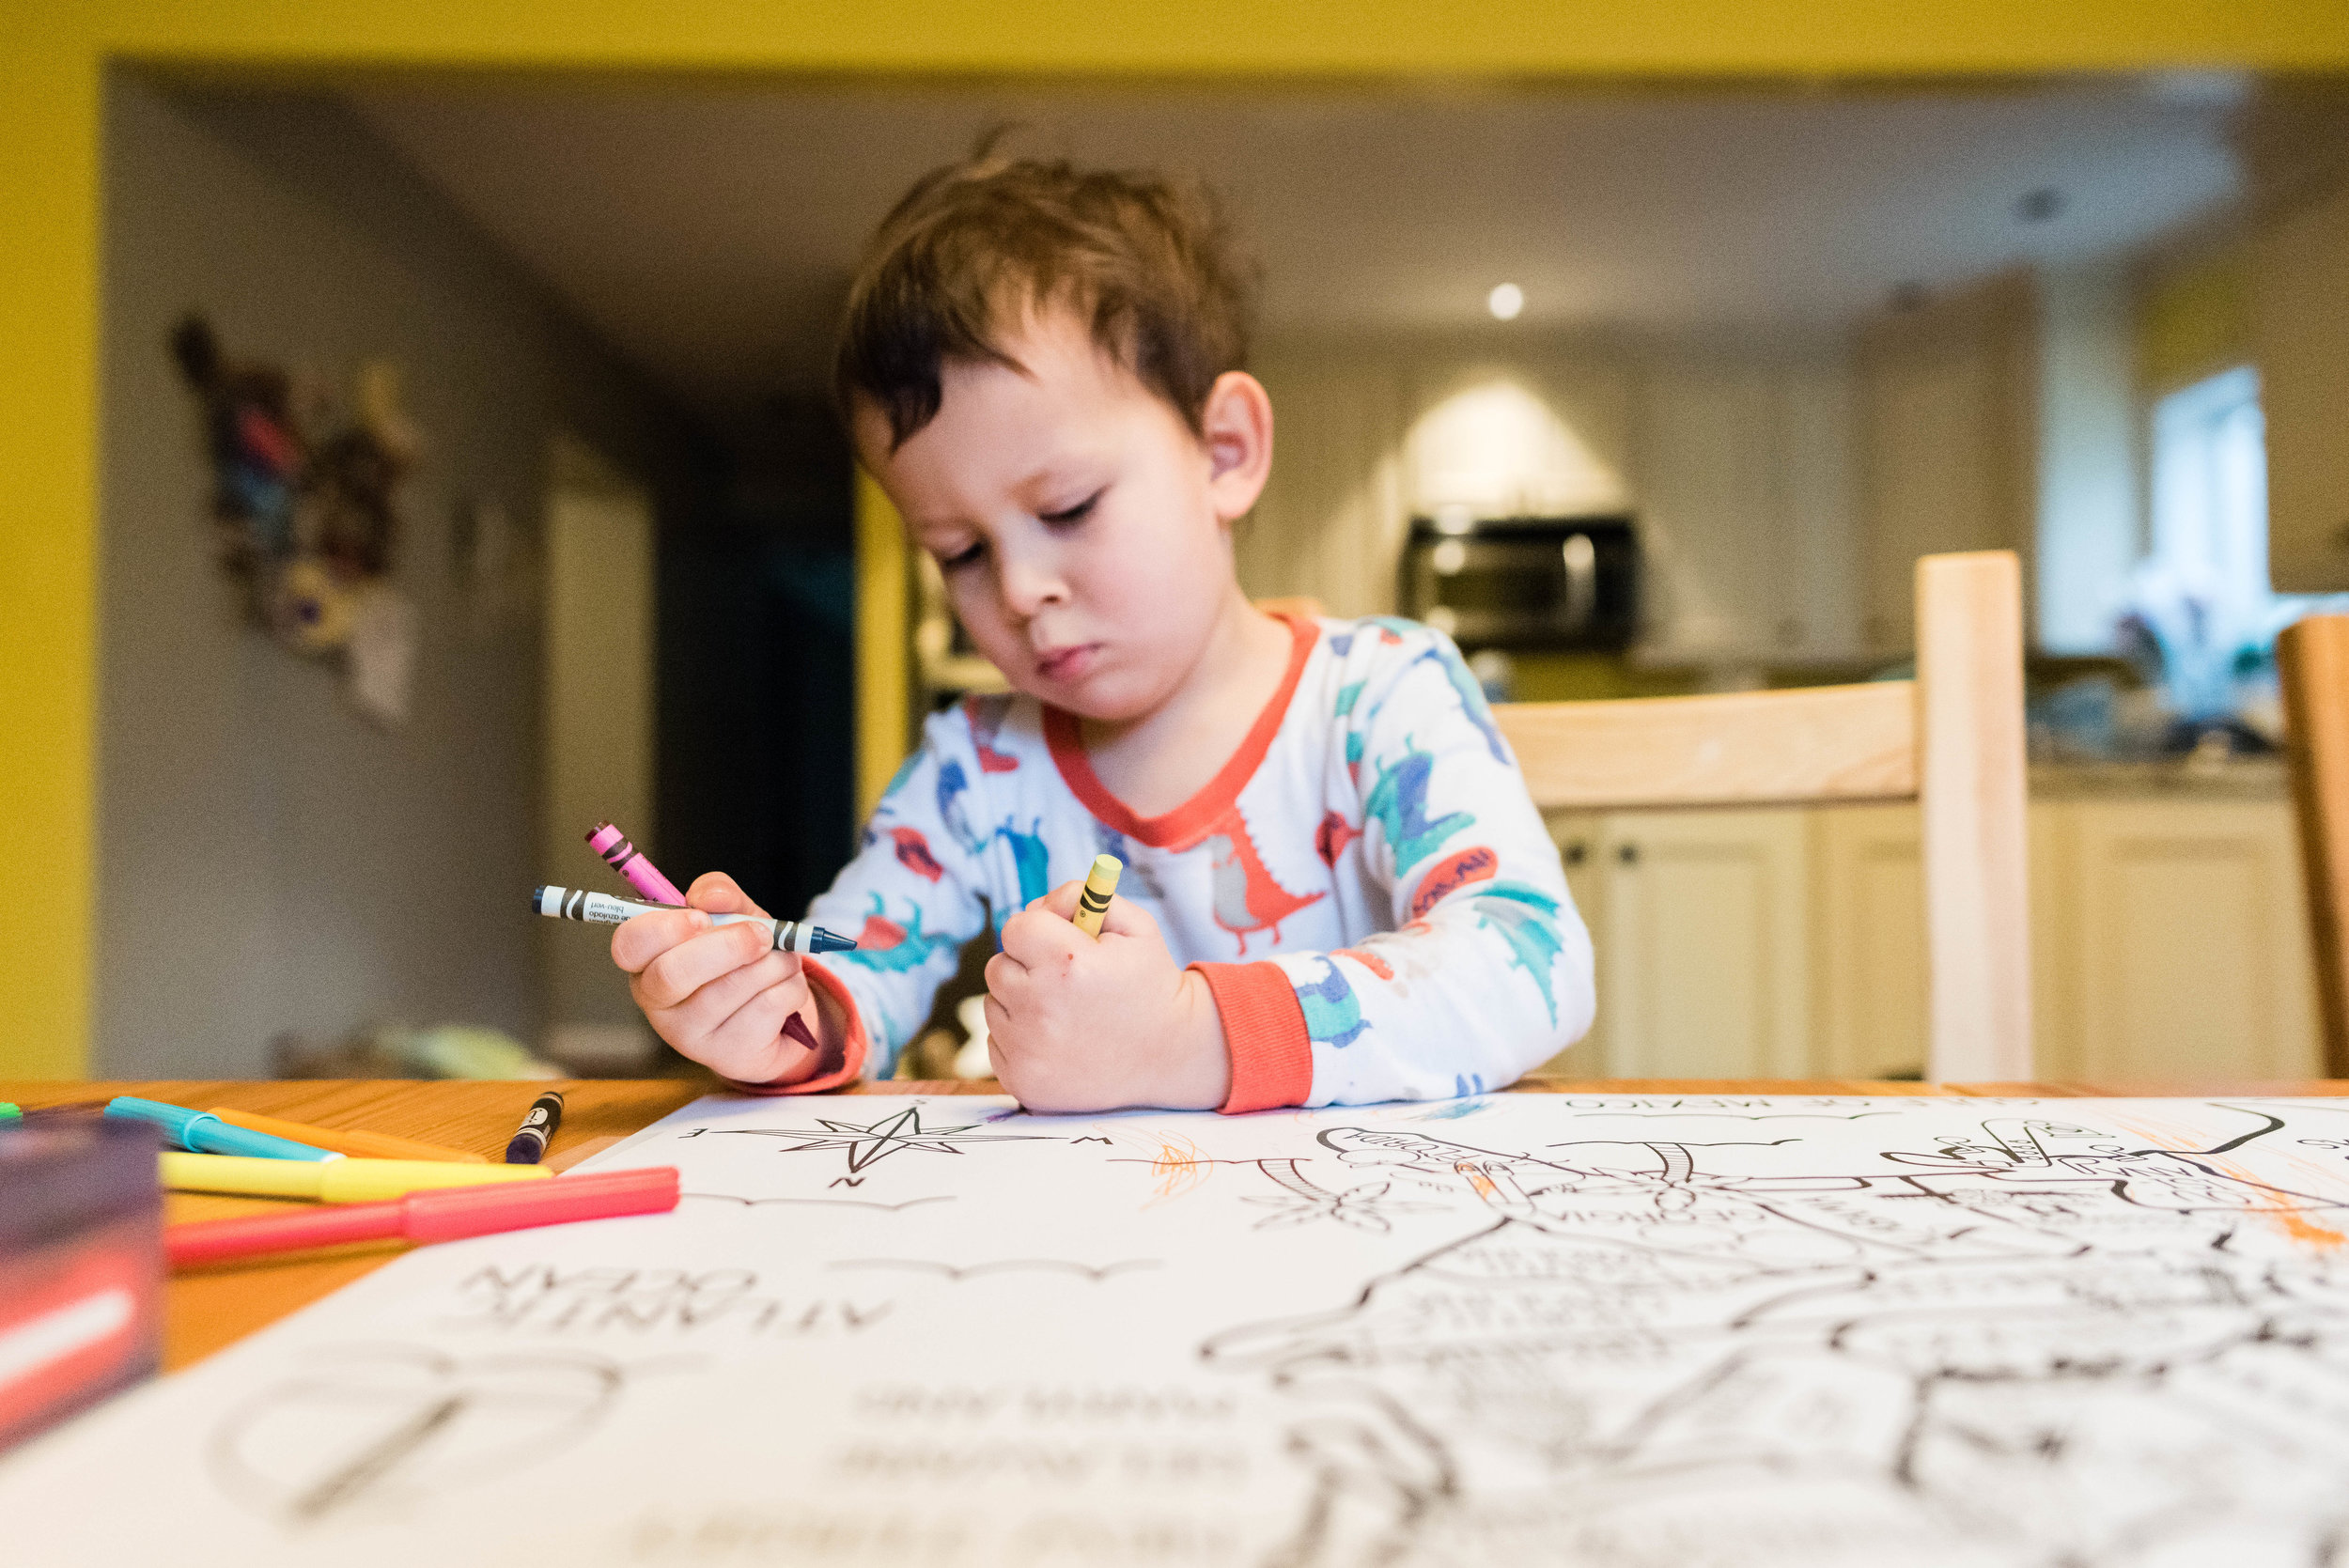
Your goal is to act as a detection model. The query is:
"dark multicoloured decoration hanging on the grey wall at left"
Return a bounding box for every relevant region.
[172,315,421,723]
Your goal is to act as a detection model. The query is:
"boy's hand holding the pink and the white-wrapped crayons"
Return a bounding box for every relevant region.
[611,871,844,1084]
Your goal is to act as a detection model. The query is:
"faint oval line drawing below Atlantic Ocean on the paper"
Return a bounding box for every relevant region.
[207,1345,625,1526]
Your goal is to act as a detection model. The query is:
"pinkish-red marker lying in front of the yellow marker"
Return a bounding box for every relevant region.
[163,1164,677,1267]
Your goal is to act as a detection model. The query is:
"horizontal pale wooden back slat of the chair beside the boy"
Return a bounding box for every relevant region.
[1494,681,1917,812]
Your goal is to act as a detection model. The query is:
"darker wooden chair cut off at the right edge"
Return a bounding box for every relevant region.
[2277,615,2349,1078]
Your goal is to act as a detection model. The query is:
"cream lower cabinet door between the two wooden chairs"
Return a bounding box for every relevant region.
[2070,800,2319,1082]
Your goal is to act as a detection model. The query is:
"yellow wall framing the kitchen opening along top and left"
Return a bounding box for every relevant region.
[0,0,2349,1073]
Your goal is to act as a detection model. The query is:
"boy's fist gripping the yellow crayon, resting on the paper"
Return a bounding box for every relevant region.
[987,882,1231,1112]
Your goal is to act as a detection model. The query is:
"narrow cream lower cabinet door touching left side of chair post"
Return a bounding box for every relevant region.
[1812,805,1931,1078]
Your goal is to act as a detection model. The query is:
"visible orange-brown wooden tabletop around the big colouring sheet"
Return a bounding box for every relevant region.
[0,1078,2349,1371]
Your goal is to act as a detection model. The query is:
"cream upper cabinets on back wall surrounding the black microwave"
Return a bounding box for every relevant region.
[1234,340,1860,667]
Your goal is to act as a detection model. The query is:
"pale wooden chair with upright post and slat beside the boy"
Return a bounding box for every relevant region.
[1494,550,2039,1082]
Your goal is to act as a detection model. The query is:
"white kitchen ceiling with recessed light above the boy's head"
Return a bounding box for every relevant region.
[352,80,2239,411]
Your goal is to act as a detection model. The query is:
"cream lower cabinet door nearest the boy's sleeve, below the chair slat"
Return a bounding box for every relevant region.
[1595,810,1812,1078]
